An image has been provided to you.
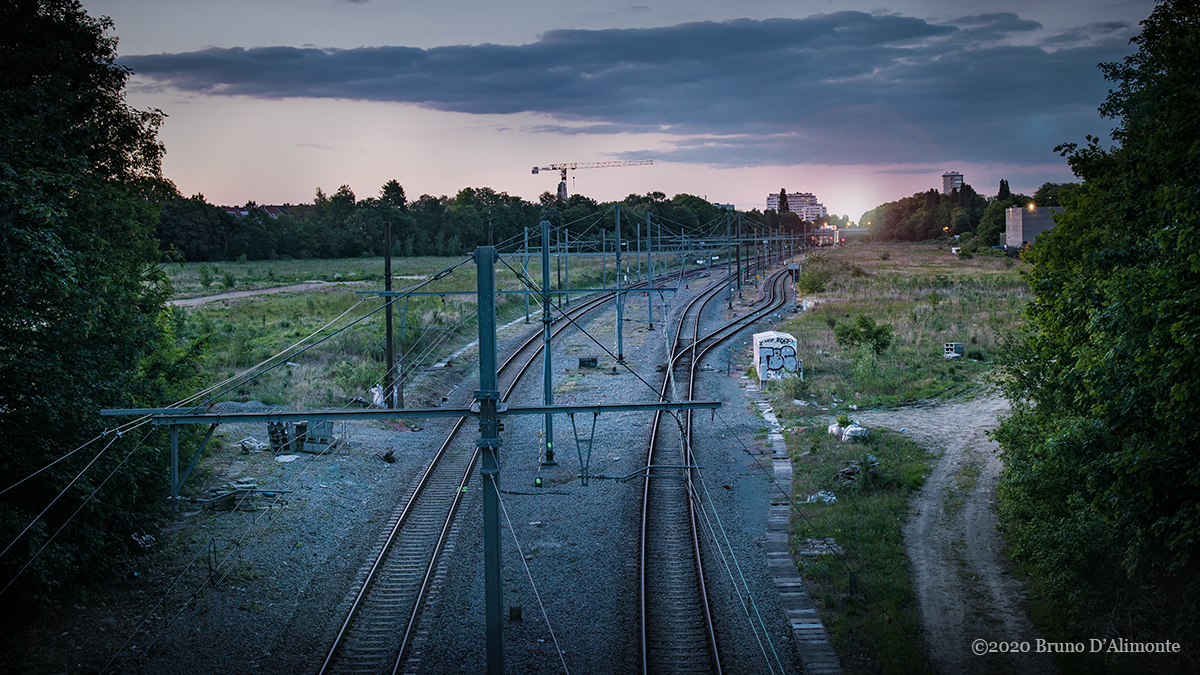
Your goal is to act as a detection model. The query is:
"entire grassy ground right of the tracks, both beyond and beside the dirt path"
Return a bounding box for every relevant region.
[766,239,1030,674]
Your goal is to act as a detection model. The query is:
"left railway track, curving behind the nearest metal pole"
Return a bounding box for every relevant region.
[319,282,636,675]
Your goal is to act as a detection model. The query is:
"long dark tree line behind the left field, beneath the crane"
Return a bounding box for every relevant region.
[157,180,748,262]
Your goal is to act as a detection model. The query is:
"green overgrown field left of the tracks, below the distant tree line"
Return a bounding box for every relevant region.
[168,253,648,407]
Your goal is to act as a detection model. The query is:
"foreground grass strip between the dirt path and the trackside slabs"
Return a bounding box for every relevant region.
[786,428,929,674]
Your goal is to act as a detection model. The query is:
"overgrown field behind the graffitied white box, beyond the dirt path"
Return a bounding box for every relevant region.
[778,244,1030,406]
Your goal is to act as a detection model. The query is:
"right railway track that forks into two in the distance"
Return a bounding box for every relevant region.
[640,265,785,674]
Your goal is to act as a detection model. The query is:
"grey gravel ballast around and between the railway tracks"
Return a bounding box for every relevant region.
[32,273,799,675]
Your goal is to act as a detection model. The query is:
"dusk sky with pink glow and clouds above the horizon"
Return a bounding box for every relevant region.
[83,0,1153,220]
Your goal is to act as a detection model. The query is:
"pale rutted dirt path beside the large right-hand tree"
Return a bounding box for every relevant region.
[854,396,1057,675]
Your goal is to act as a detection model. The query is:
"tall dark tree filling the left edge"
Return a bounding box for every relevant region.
[0,0,194,653]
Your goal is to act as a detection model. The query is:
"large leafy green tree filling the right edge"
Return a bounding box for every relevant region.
[997,0,1200,671]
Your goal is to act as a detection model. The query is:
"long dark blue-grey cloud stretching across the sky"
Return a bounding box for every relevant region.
[121,12,1129,166]
